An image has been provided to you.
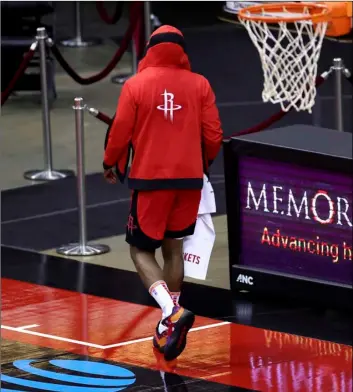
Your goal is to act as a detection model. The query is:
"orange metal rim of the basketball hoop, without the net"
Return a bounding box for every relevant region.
[238,3,331,23]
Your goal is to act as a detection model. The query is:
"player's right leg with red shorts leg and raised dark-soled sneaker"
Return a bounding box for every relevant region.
[158,190,201,360]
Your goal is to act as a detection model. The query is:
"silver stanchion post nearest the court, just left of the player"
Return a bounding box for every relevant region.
[56,98,110,256]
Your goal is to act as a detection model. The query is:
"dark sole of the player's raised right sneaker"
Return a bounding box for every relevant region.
[163,310,195,361]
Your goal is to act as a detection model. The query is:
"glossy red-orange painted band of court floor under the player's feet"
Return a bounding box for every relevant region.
[1,279,352,392]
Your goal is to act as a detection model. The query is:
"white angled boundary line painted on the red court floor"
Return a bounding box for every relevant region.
[1,321,230,350]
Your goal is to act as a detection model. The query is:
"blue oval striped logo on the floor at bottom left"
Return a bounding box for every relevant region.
[1,359,136,392]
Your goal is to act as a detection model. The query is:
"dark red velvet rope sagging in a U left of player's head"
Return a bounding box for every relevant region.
[51,1,143,85]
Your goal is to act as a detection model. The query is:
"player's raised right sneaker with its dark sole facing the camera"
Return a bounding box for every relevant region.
[161,305,195,361]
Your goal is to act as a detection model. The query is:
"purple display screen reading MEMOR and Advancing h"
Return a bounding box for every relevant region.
[239,157,353,285]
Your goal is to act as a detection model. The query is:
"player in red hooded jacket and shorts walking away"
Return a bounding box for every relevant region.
[103,26,223,361]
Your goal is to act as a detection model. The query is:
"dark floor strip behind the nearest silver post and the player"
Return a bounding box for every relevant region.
[1,173,225,250]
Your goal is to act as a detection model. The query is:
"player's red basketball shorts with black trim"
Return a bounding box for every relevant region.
[126,189,201,251]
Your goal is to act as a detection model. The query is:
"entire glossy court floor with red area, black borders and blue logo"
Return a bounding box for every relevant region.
[1,247,352,392]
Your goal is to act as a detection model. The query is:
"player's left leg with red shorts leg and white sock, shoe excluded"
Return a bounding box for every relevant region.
[126,191,174,319]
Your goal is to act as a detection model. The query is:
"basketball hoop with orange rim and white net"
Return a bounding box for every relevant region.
[238,2,330,113]
